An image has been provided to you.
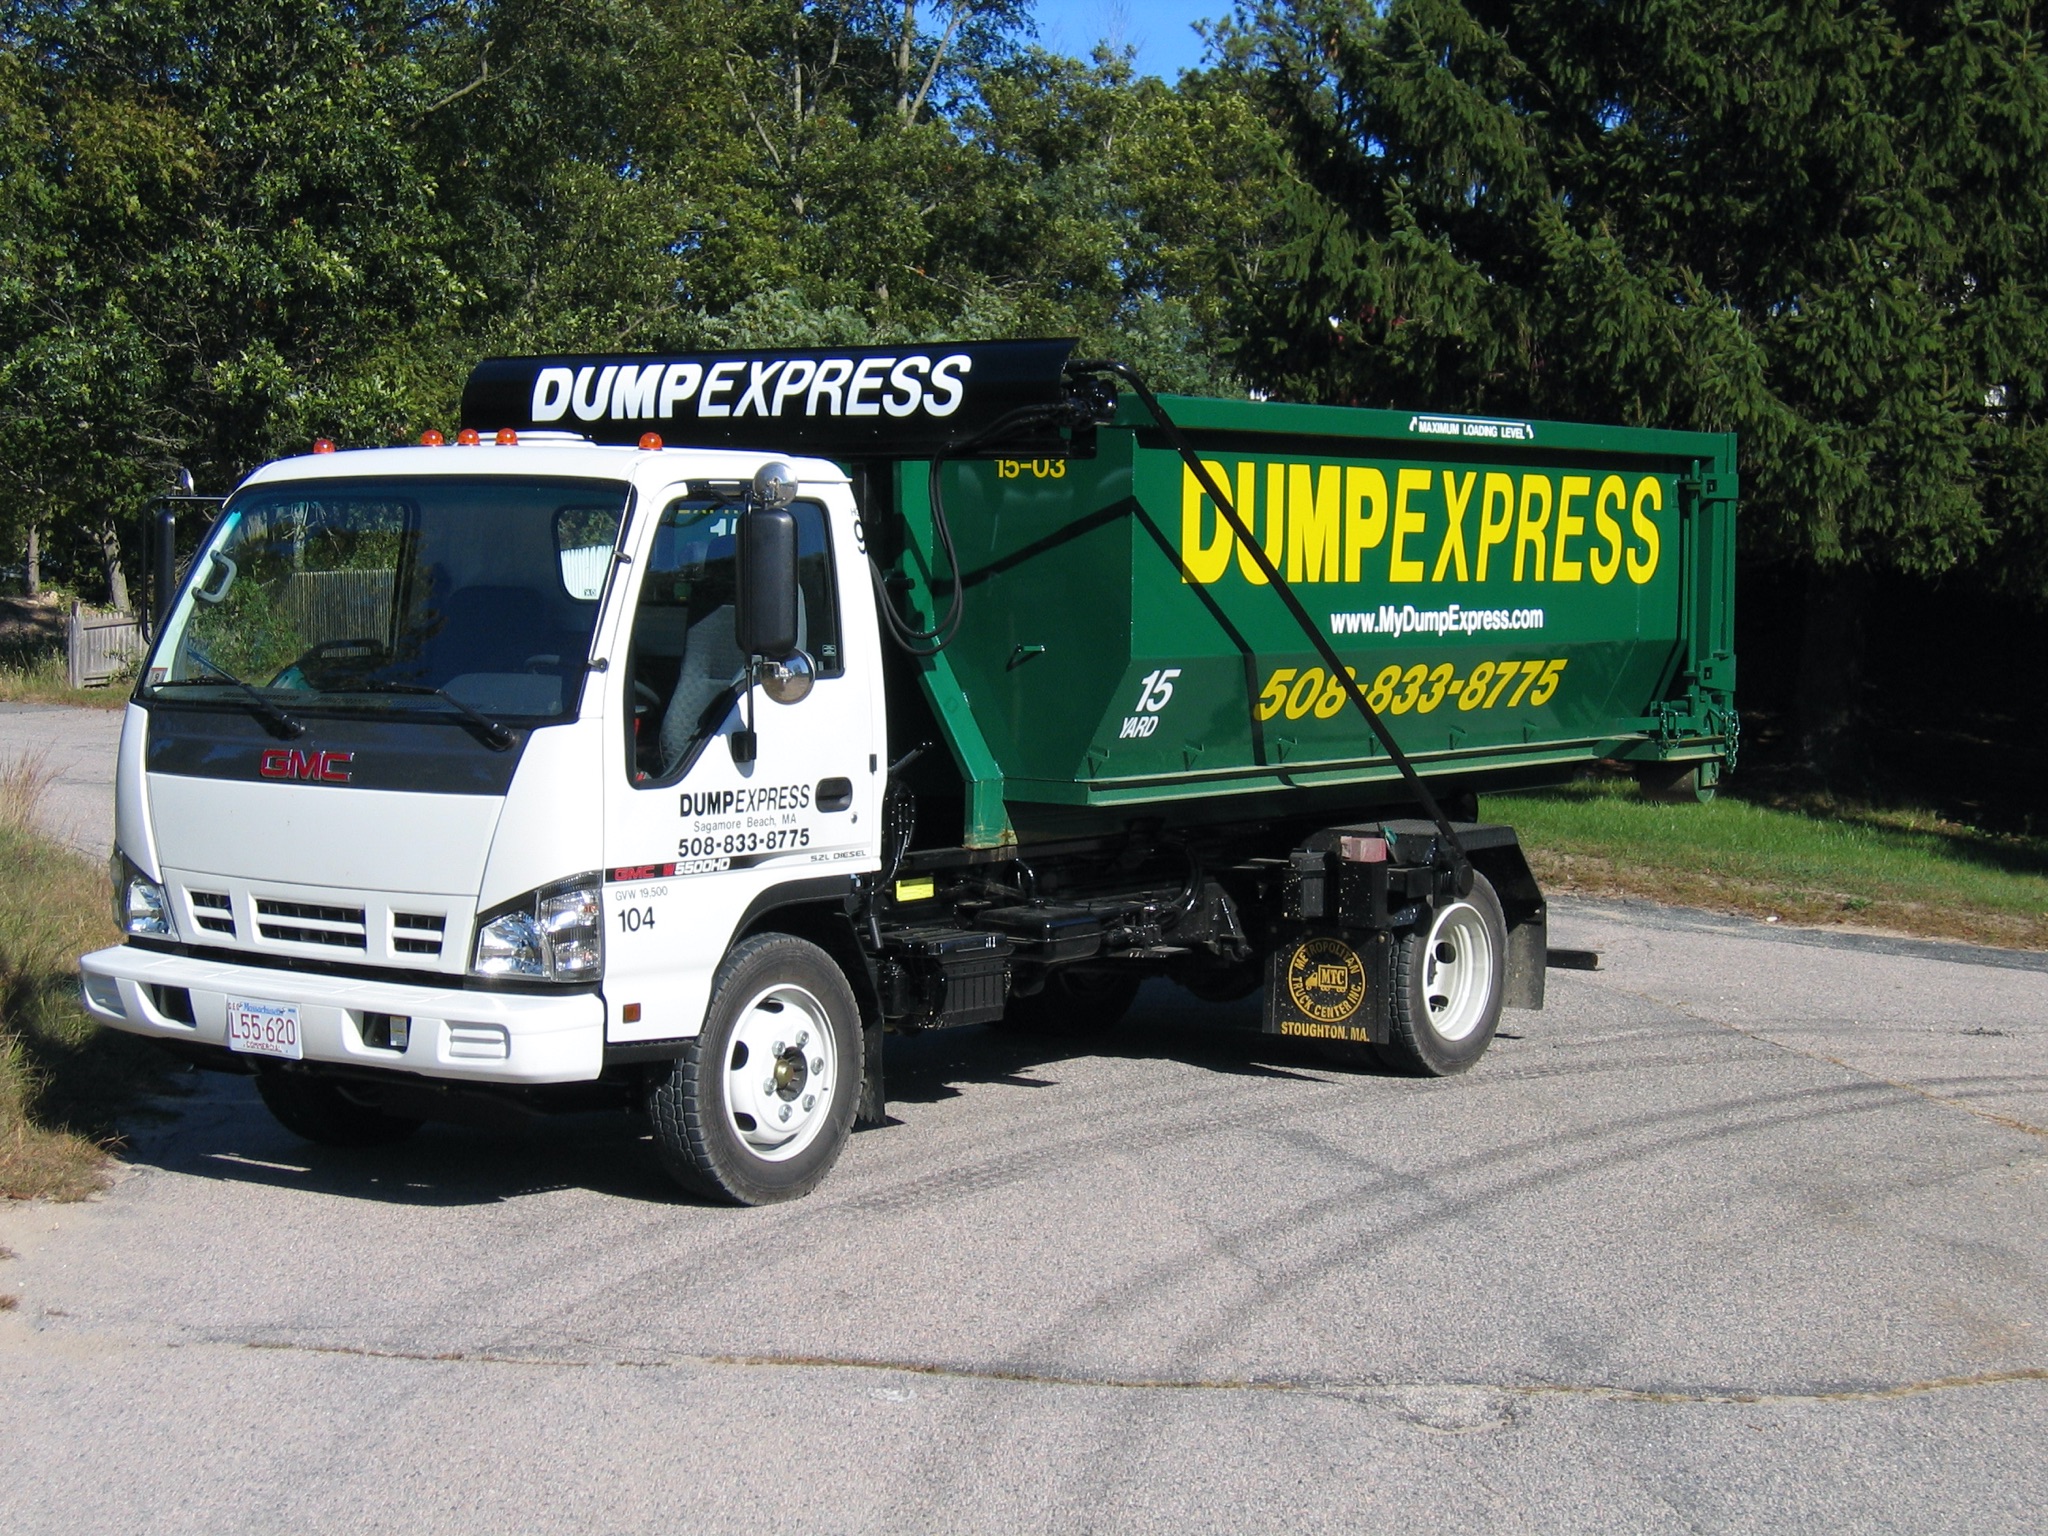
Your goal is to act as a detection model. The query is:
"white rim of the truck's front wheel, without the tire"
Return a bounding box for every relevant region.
[725,981,840,1163]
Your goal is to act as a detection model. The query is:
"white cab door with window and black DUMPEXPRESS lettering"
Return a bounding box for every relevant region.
[604,487,881,1040]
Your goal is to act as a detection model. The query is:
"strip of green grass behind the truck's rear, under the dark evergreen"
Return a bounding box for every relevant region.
[1481,780,2048,948]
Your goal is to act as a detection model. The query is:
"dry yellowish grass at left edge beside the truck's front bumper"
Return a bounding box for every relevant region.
[0,798,164,1200]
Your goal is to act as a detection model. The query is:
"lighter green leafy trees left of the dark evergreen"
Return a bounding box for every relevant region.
[0,0,1280,596]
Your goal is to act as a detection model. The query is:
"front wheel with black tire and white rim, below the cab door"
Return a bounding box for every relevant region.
[647,934,862,1206]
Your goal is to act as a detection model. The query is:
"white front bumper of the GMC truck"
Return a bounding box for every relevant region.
[78,944,604,1083]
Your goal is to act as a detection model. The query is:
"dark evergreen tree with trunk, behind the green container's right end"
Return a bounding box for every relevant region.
[1231,0,2048,768]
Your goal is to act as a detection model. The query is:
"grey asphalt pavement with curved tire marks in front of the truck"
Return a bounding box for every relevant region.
[0,708,2048,1536]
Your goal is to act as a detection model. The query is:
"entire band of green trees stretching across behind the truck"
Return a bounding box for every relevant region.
[0,0,2048,647]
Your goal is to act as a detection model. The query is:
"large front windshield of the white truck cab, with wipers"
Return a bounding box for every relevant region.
[141,475,627,719]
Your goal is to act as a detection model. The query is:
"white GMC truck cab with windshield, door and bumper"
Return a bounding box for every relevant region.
[82,432,885,1204]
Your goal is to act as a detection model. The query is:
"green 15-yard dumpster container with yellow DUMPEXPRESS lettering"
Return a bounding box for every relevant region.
[893,395,1737,846]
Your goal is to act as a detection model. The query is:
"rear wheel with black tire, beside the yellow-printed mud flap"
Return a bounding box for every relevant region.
[1386,870,1507,1077]
